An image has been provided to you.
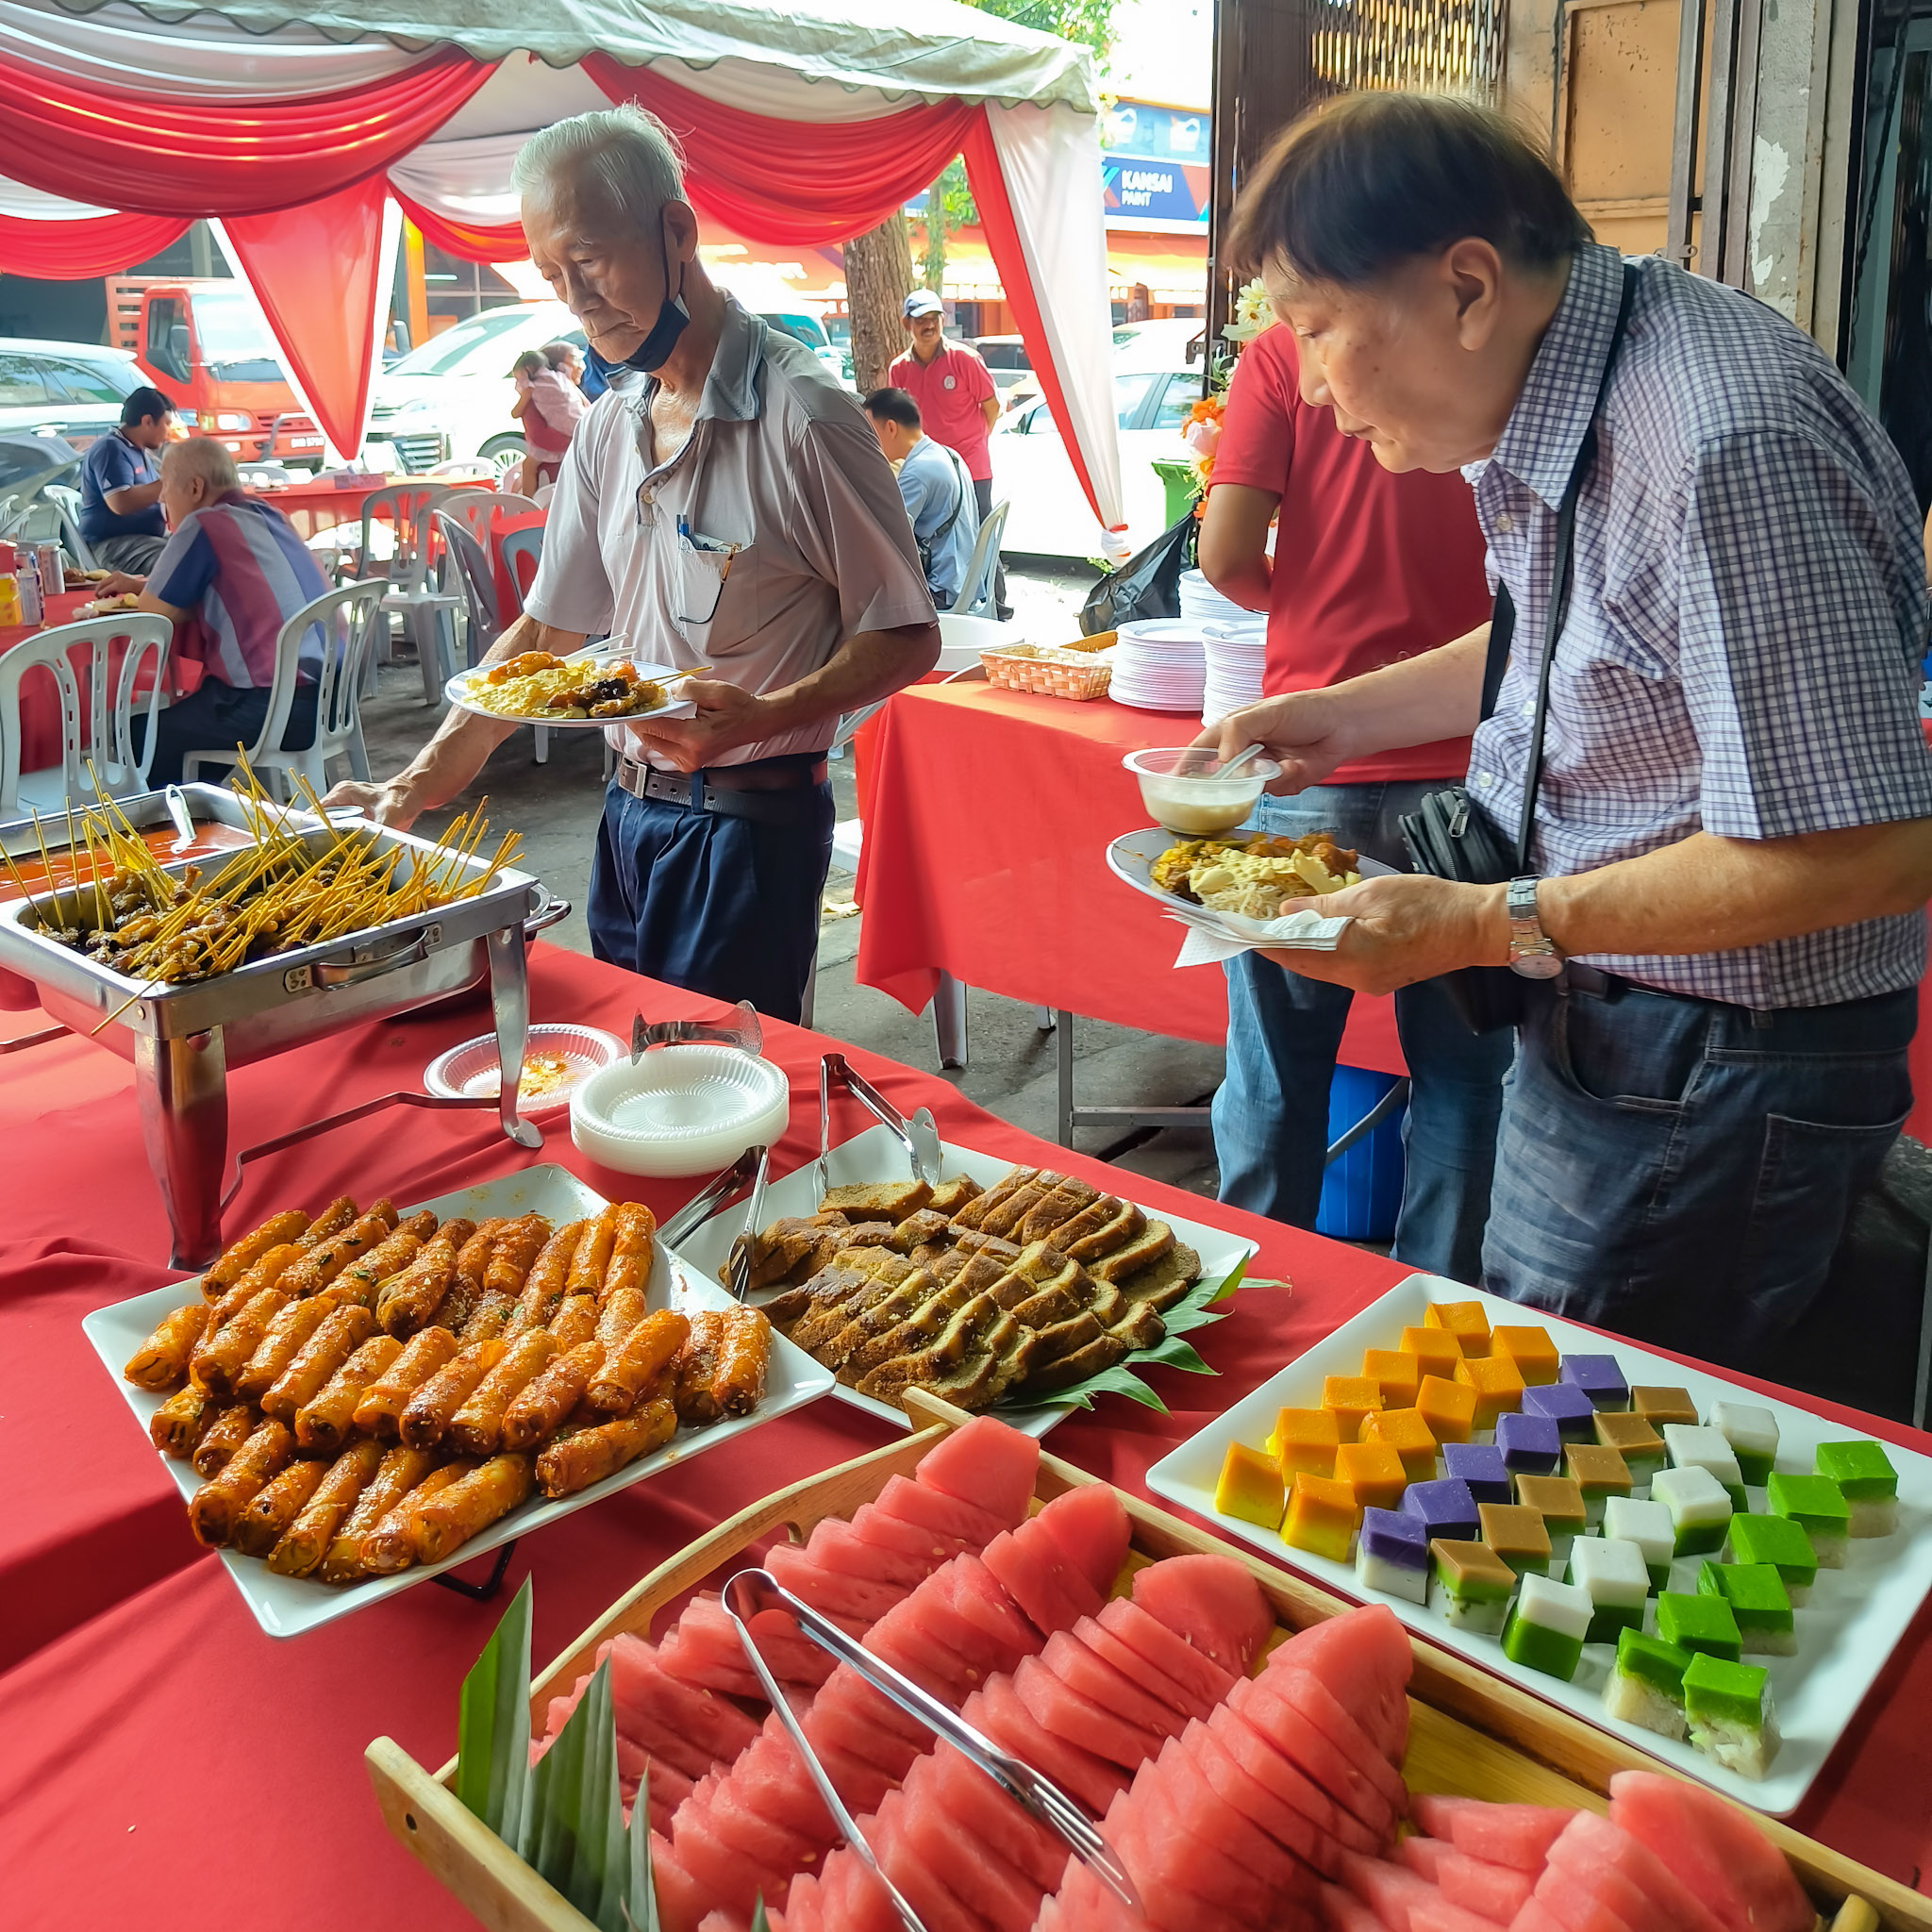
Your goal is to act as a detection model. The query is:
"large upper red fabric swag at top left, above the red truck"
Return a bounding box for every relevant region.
[0,48,494,217]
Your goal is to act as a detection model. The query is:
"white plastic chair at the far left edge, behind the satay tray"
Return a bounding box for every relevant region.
[0,610,174,819]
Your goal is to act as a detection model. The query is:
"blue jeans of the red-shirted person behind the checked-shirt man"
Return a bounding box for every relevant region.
[1213,780,1515,1281]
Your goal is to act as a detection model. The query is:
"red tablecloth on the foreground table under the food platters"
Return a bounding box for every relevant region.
[0,947,1932,1932]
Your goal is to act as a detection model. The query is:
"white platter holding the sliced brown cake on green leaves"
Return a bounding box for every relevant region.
[676,1126,1256,1436]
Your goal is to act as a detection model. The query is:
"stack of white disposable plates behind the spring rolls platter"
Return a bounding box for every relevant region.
[570,1045,792,1176]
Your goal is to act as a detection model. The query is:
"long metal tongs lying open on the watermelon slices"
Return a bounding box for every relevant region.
[723,1568,1140,1932]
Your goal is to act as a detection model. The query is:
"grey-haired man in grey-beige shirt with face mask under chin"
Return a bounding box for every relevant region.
[328,108,939,1020]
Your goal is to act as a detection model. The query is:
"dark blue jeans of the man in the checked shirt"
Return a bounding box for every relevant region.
[1482,979,1919,1370]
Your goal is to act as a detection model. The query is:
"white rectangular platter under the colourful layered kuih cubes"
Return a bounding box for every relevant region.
[1148,1275,1932,1818]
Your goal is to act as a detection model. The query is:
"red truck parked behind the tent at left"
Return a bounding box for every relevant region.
[107,275,323,470]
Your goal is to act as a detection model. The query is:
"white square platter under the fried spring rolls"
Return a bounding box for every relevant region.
[81,1165,833,1637]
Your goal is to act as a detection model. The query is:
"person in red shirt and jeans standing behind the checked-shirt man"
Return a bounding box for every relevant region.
[1200,325,1513,1281]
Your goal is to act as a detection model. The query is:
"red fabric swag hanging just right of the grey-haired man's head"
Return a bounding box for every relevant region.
[583,54,985,247]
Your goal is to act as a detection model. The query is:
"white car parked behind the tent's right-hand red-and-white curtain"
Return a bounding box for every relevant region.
[991,369,1202,557]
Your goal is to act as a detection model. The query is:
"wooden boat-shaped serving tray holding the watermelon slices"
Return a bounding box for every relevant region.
[363,1390,1932,1932]
